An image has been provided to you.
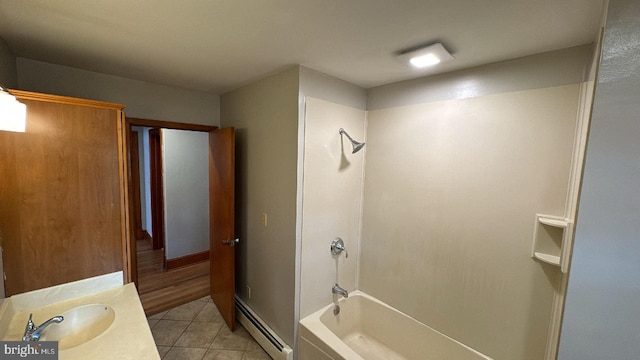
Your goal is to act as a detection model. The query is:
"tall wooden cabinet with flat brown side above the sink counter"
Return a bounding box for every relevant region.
[0,90,128,296]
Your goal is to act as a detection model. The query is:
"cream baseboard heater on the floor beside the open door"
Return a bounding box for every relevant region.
[236,296,293,360]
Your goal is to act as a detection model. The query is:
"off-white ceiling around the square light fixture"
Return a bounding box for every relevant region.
[0,0,603,94]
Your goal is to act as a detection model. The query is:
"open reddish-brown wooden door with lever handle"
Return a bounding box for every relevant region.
[209,128,236,331]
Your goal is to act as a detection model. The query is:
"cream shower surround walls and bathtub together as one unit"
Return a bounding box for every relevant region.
[298,79,582,360]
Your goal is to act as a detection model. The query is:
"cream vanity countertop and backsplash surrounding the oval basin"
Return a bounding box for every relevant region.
[0,275,160,360]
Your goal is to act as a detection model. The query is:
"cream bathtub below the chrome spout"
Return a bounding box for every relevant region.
[298,291,491,360]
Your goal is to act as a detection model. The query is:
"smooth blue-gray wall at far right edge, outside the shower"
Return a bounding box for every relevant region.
[558,0,640,360]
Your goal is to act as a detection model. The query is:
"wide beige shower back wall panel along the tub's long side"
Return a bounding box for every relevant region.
[359,85,579,360]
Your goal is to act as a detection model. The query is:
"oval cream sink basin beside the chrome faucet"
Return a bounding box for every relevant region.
[40,304,116,350]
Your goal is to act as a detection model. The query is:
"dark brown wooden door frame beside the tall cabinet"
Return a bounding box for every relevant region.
[123,117,218,288]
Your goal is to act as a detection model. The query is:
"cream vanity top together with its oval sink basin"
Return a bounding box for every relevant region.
[0,282,160,360]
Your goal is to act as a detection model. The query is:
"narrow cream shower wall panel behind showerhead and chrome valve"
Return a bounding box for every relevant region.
[300,97,366,318]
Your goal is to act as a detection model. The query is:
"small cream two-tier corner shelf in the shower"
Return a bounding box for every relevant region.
[531,214,573,273]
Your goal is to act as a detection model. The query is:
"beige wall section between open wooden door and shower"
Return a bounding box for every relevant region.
[220,67,299,345]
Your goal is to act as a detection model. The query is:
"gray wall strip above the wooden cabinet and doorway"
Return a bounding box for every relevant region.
[17,58,220,126]
